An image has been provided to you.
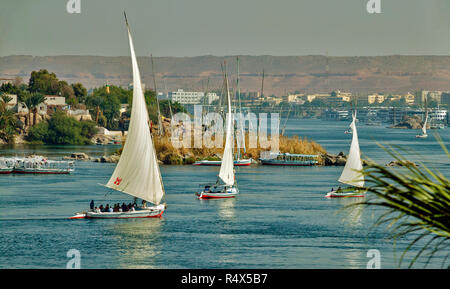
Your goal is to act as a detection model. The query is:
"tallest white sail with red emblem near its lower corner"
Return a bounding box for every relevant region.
[106,19,164,205]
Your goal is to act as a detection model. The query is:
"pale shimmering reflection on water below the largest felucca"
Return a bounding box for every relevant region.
[109,218,164,269]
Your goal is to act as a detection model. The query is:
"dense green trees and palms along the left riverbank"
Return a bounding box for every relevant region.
[0,69,186,144]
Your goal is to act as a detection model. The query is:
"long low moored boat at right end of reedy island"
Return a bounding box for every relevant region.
[259,151,319,166]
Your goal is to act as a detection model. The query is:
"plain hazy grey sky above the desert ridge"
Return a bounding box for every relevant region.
[0,0,450,56]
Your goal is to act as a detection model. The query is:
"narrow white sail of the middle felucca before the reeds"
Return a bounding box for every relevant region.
[219,74,234,186]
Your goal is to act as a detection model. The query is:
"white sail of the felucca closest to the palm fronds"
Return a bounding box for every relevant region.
[339,114,364,187]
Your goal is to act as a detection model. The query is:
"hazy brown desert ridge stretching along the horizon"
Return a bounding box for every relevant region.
[0,55,450,96]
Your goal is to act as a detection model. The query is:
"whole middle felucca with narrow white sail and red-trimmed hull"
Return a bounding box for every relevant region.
[195,62,239,199]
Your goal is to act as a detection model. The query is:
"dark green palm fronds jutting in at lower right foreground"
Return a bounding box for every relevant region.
[352,139,450,268]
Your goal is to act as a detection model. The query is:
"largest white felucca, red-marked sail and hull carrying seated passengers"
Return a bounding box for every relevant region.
[71,15,166,219]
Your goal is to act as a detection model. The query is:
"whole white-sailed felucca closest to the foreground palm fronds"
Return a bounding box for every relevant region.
[325,112,364,198]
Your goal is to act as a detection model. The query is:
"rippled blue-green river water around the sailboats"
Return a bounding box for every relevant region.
[0,120,450,268]
